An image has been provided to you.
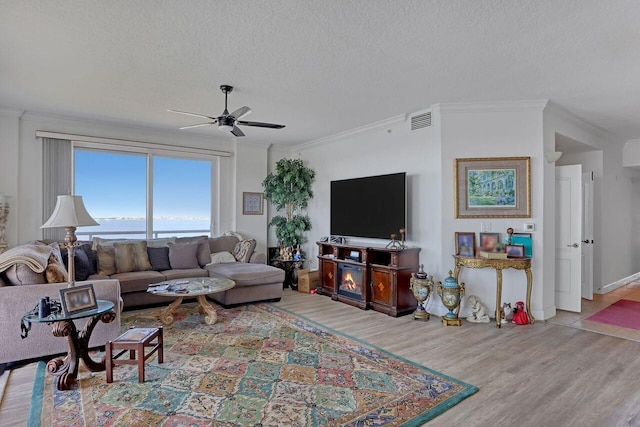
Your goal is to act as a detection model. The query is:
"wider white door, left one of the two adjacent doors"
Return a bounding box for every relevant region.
[555,165,582,312]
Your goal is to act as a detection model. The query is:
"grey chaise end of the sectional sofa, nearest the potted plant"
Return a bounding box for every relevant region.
[205,262,284,307]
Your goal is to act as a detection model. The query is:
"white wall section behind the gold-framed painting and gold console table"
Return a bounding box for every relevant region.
[434,101,544,319]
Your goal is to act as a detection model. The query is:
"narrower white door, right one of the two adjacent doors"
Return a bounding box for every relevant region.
[580,171,593,300]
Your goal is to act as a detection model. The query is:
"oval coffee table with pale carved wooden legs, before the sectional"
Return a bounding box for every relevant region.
[147,277,236,326]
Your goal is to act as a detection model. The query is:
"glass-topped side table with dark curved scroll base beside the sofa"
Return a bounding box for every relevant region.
[22,300,116,390]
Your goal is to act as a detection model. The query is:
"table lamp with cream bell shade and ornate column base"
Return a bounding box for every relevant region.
[40,196,100,287]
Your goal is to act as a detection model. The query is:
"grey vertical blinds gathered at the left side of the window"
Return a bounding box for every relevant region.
[42,138,73,240]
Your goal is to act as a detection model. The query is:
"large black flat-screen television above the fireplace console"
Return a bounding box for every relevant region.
[330,172,407,239]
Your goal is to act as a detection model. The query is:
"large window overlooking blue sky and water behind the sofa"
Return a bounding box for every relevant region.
[74,147,213,240]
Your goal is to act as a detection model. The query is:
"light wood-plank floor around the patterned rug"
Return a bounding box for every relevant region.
[0,290,640,427]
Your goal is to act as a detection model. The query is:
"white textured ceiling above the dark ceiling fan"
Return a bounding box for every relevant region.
[0,0,640,144]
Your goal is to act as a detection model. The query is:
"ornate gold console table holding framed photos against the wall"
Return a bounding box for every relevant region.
[453,255,536,328]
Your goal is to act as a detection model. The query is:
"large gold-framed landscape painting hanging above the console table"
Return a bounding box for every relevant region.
[454,157,531,218]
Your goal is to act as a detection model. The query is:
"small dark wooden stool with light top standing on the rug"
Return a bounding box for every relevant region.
[104,326,164,383]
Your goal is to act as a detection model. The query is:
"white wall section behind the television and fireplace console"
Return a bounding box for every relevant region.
[295,116,441,275]
